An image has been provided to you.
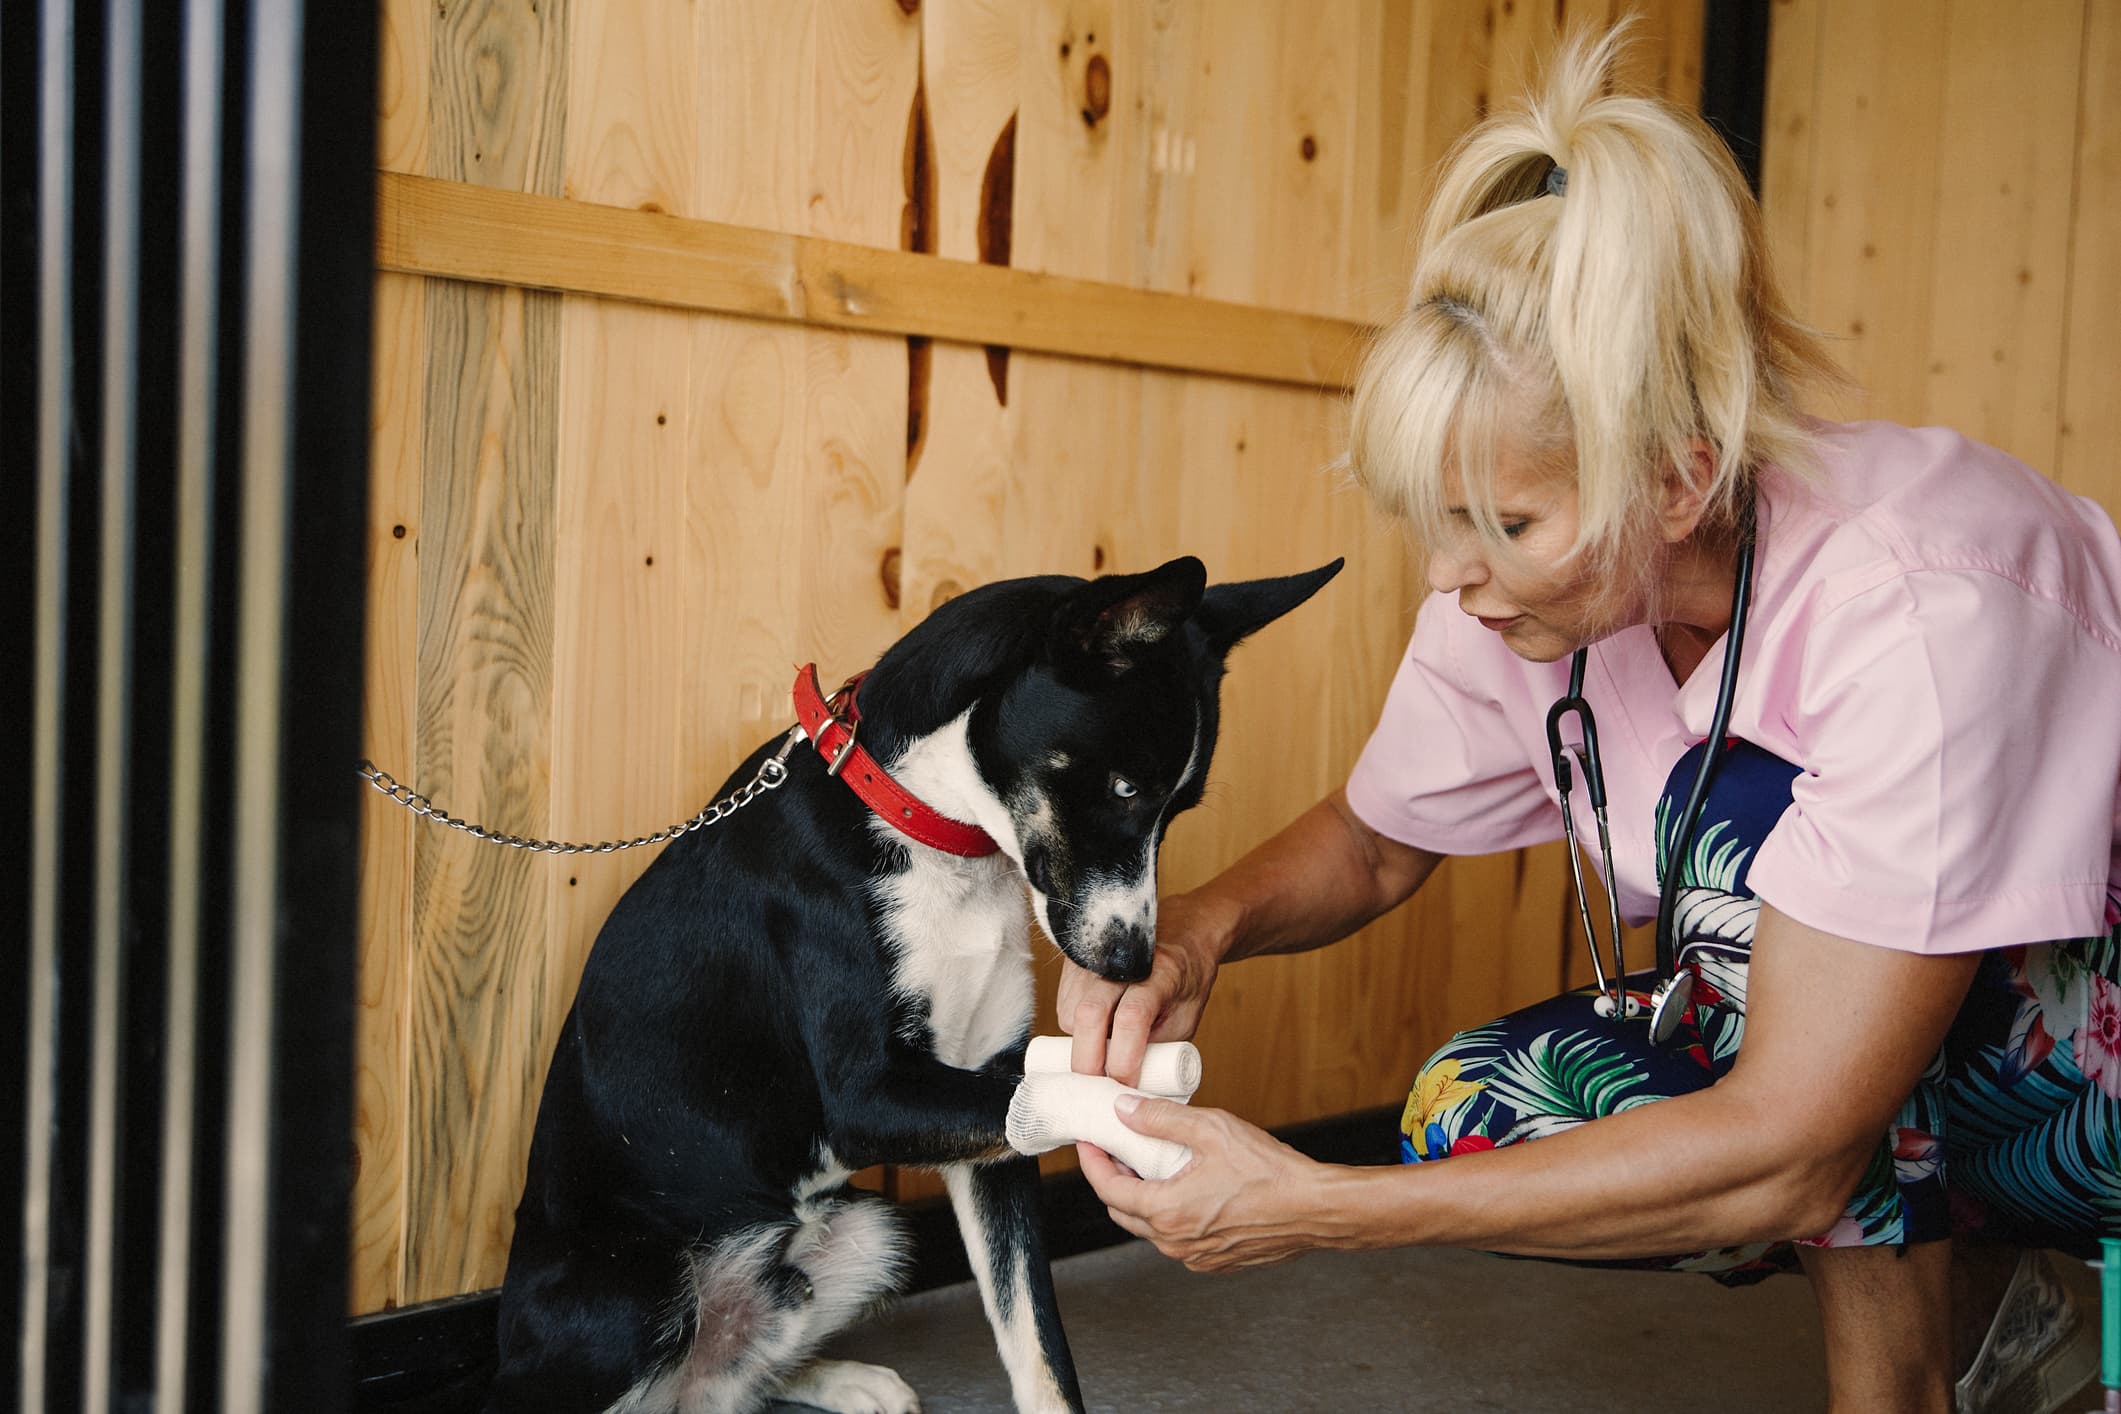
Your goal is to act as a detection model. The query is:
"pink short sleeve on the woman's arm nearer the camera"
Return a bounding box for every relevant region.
[1750,570,2121,952]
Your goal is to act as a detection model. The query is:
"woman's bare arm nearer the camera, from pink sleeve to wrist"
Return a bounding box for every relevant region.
[1319,905,1981,1259]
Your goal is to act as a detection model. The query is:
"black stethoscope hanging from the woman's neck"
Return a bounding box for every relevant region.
[1546,517,1752,1045]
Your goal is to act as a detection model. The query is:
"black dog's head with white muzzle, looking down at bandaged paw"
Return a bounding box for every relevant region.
[969,558,1340,982]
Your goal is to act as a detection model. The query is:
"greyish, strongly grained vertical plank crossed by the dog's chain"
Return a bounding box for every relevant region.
[405,0,568,1300]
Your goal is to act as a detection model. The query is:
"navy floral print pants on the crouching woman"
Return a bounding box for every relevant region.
[1400,742,2121,1285]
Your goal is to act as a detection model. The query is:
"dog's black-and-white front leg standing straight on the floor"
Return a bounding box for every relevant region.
[942,1157,1082,1414]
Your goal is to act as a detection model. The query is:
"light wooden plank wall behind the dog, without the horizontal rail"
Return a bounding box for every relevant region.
[350,0,1701,1312]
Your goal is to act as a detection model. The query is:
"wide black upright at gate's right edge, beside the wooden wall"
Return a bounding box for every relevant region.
[267,4,375,1382]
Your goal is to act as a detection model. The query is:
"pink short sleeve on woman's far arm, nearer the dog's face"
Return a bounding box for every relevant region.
[1347,596,1561,854]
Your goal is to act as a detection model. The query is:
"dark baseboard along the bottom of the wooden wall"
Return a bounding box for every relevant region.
[348,1109,1400,1414]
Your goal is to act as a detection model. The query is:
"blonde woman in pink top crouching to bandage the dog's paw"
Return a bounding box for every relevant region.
[1061,24,2121,1412]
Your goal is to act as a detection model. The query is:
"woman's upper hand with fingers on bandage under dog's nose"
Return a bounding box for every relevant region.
[1056,895,1232,1085]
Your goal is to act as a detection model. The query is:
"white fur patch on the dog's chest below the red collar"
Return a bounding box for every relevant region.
[878,854,1031,1068]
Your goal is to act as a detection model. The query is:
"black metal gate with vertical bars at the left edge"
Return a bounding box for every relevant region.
[0,0,375,1414]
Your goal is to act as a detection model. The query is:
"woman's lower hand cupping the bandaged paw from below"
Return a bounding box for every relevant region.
[1075,1100,1347,1272]
